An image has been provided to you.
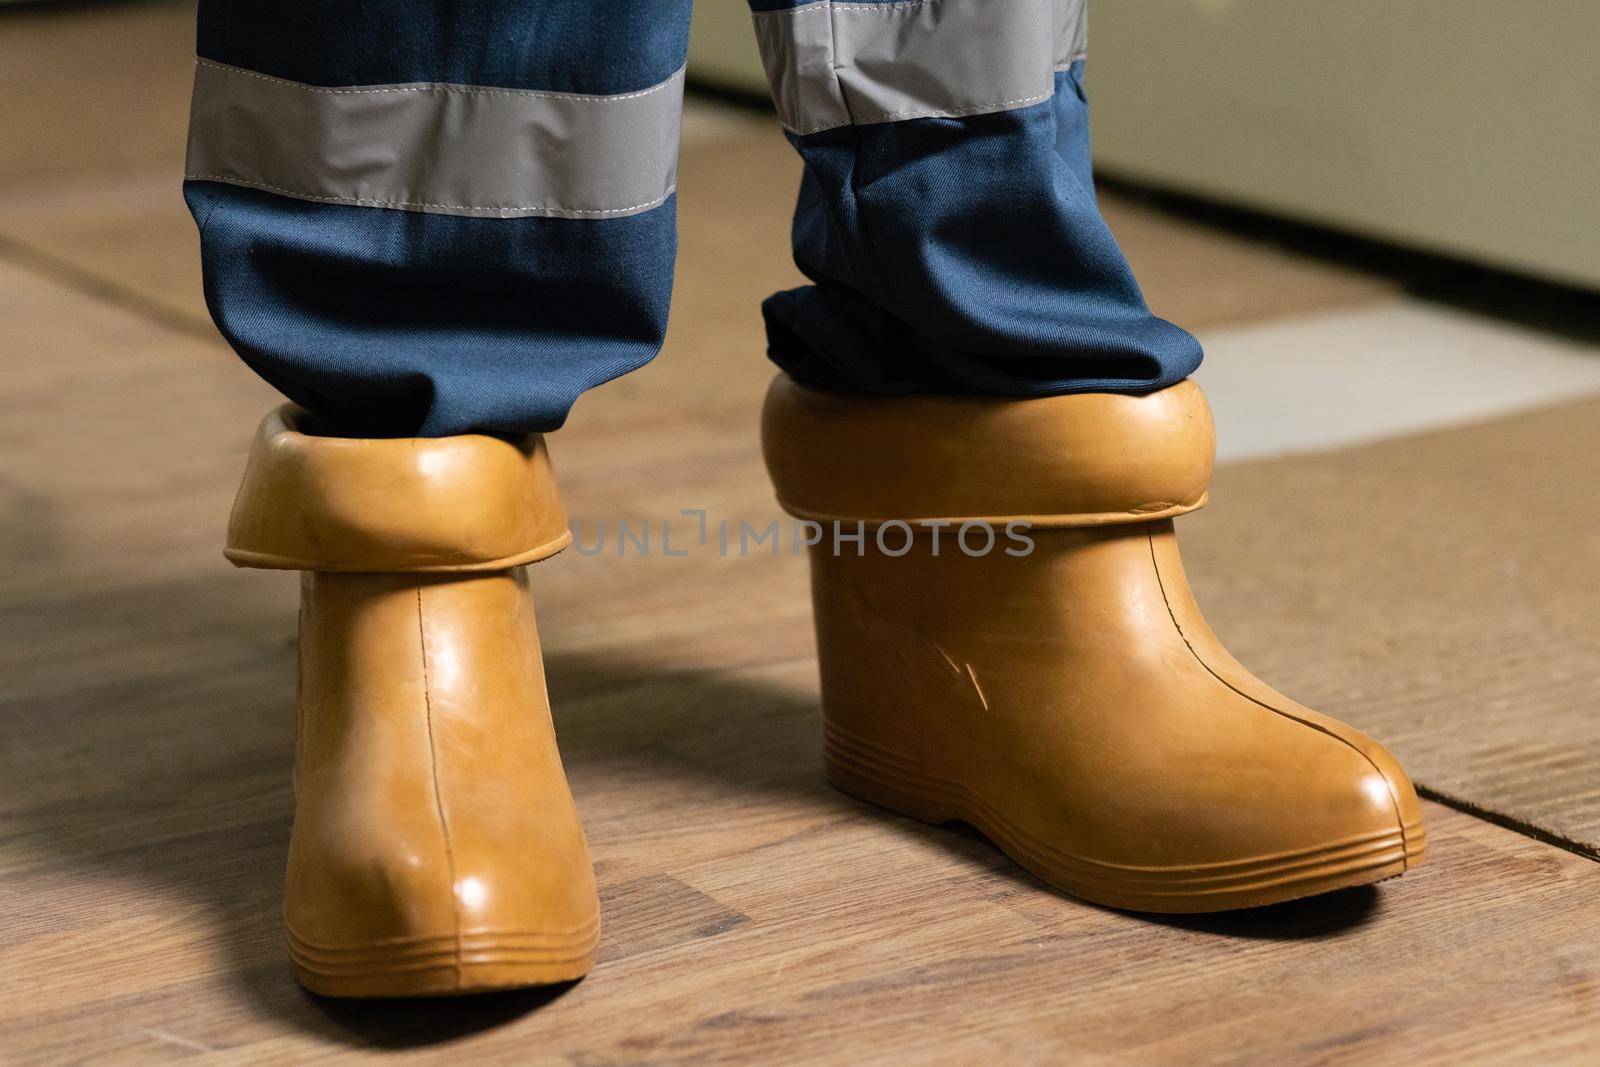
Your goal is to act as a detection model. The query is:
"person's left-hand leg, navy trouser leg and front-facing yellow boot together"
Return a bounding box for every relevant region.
[186,0,688,997]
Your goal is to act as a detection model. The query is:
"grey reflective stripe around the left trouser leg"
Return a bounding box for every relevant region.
[184,59,683,219]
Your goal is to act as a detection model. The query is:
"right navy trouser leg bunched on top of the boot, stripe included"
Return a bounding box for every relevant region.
[750,0,1200,397]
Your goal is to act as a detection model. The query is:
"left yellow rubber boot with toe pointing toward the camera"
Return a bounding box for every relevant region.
[227,408,600,997]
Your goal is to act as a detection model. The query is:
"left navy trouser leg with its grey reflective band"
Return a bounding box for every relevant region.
[186,0,688,437]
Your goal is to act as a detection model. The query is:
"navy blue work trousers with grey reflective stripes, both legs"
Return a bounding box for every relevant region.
[184,0,1200,437]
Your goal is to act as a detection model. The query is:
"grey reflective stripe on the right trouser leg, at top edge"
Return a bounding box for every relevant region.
[754,0,1086,134]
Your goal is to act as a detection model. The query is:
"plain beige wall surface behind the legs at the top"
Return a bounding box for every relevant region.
[690,0,1600,286]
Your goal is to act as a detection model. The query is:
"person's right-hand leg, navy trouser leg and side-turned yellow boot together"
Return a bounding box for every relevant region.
[754,0,1426,912]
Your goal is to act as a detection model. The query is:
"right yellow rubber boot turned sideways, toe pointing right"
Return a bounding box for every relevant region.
[763,376,1426,912]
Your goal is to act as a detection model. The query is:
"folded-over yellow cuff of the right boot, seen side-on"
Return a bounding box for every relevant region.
[762,374,1216,526]
